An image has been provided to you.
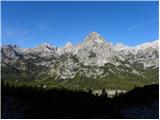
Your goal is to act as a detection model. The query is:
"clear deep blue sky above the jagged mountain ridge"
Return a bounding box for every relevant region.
[1,1,158,47]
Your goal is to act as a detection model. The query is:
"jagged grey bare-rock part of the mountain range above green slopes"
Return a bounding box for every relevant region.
[1,32,159,79]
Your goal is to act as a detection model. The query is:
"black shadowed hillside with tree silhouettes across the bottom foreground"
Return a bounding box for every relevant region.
[1,82,159,119]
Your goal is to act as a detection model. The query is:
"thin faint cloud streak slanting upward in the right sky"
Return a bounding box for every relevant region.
[127,19,158,31]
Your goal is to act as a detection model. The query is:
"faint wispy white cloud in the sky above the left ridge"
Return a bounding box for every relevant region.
[1,22,53,46]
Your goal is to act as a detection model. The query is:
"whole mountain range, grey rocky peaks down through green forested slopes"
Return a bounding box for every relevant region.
[1,32,159,90]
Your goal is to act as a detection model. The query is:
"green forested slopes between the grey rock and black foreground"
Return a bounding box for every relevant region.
[2,63,159,91]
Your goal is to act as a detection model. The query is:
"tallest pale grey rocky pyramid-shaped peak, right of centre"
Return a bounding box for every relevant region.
[76,32,115,66]
